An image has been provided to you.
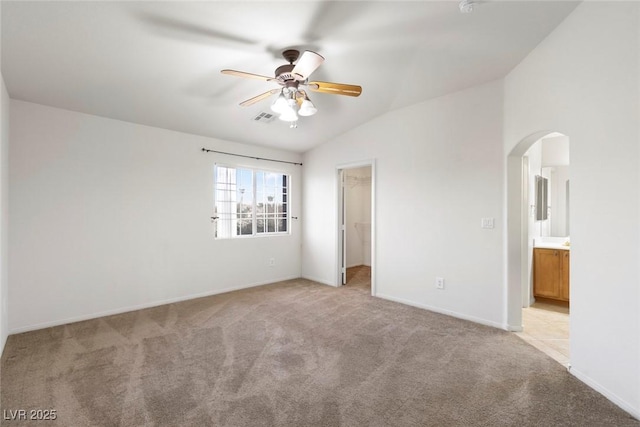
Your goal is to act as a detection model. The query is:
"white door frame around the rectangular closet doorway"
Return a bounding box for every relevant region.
[335,159,376,296]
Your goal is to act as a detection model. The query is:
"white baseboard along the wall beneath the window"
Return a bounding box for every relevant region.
[9,276,299,335]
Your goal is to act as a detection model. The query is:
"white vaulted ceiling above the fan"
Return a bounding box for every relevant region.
[1,1,577,152]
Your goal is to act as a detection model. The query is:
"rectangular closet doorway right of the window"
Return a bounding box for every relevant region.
[337,161,375,295]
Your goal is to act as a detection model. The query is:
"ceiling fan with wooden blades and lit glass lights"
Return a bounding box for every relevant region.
[221,49,362,128]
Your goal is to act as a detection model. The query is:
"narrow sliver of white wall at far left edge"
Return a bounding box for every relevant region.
[0,75,9,355]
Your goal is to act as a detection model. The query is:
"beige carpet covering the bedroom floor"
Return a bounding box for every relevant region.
[0,280,640,427]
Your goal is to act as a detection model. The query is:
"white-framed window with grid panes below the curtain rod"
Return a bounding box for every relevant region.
[214,165,289,239]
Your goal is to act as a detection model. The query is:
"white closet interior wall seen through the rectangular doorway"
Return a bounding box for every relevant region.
[345,166,371,267]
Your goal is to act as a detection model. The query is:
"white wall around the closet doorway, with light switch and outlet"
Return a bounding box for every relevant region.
[302,82,504,326]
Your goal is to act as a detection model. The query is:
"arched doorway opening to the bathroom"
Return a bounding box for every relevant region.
[507,132,570,365]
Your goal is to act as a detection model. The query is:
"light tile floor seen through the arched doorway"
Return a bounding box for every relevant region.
[516,302,570,366]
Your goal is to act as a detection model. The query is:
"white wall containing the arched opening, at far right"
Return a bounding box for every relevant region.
[504,2,640,417]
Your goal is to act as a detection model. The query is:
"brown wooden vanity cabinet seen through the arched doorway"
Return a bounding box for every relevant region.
[533,248,571,302]
